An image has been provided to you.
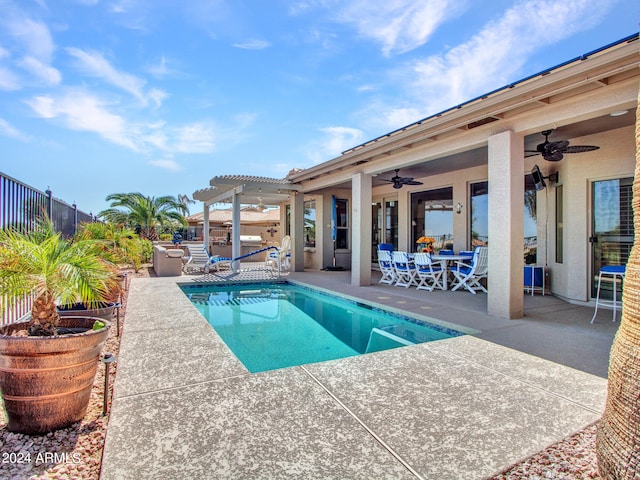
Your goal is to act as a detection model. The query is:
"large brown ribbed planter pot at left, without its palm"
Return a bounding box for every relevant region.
[0,317,110,435]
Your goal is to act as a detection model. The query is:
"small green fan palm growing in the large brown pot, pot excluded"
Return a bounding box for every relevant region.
[0,219,117,335]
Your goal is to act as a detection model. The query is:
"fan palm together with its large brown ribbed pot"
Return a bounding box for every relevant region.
[0,220,117,434]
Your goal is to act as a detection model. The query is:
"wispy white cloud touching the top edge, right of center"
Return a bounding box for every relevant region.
[333,0,467,56]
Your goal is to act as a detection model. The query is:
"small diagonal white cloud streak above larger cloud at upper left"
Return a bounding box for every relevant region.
[67,47,167,106]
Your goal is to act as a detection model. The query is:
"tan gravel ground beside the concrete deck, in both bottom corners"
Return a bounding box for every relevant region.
[0,268,599,480]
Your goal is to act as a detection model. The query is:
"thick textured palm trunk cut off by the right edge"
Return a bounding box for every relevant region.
[596,88,640,474]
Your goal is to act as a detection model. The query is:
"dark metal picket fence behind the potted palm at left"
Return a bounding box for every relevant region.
[0,172,94,325]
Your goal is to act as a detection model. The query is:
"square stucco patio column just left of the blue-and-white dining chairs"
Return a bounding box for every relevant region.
[351,173,371,287]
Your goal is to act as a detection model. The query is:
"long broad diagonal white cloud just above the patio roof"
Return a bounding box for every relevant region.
[361,0,615,129]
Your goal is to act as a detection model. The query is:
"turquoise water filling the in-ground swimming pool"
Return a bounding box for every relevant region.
[182,283,462,373]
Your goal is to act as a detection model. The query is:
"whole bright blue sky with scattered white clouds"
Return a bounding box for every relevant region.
[0,0,640,213]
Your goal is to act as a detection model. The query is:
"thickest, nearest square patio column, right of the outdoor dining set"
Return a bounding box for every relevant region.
[487,131,524,318]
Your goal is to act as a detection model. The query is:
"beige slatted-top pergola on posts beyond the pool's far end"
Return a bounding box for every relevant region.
[193,175,300,268]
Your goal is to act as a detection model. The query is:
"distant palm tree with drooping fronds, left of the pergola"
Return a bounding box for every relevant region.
[98,193,187,241]
